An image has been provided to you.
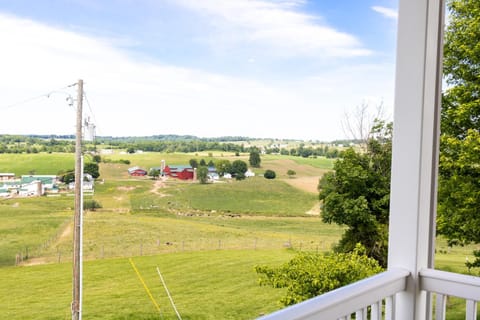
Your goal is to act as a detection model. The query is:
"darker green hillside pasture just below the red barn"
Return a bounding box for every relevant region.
[127,177,317,216]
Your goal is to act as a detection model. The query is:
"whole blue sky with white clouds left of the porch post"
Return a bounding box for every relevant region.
[0,0,397,141]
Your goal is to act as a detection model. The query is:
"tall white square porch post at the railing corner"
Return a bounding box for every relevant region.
[388,0,444,320]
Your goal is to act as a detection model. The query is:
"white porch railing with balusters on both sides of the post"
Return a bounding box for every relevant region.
[259,269,480,320]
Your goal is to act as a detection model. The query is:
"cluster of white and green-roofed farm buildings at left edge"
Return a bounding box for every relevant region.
[0,173,94,198]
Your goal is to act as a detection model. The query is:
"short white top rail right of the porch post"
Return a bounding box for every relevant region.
[420,269,480,301]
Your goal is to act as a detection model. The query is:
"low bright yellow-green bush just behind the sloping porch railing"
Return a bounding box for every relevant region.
[255,245,382,305]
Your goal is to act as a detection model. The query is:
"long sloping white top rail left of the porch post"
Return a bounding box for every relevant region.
[259,269,410,320]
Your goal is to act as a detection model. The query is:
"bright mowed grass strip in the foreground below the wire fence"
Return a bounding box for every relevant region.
[0,250,293,320]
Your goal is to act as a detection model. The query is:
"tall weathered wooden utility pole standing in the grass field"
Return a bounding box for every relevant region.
[72,79,83,320]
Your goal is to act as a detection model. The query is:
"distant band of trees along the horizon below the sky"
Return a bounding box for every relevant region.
[0,135,340,158]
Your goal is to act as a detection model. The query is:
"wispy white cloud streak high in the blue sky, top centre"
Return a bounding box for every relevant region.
[175,0,371,57]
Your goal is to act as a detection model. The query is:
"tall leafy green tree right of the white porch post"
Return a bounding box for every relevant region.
[437,0,480,248]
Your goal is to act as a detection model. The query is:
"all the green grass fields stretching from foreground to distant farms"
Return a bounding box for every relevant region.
[0,151,475,319]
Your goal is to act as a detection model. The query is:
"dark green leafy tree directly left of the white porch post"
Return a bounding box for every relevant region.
[318,122,392,266]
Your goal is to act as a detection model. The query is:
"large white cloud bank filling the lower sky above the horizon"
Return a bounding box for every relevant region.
[0,14,393,140]
